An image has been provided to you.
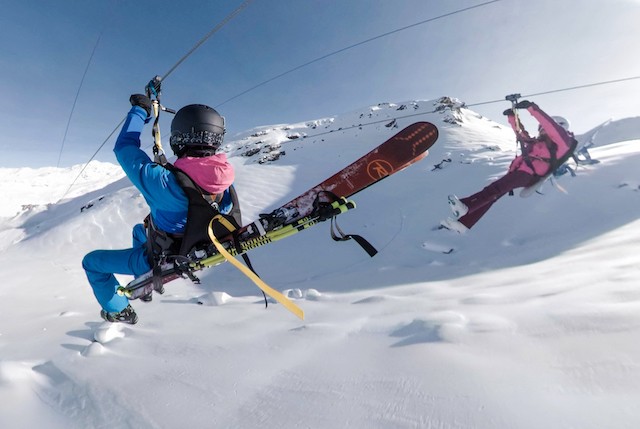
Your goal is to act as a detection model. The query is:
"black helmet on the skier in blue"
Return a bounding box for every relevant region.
[169,104,226,157]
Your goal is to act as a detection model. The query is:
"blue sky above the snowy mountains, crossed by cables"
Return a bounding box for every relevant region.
[0,0,640,167]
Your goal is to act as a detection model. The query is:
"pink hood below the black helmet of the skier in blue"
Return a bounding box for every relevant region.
[173,153,235,194]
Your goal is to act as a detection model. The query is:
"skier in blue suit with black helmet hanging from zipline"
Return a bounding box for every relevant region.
[82,94,234,324]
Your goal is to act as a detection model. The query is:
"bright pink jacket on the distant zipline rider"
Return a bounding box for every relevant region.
[508,103,573,176]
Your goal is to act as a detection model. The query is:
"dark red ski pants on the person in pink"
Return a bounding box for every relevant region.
[458,170,540,228]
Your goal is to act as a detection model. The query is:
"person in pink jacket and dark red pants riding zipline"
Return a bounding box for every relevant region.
[441,100,573,234]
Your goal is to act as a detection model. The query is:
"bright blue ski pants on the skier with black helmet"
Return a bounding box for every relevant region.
[82,224,151,313]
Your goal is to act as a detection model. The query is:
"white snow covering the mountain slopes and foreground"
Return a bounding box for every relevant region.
[0,98,640,429]
